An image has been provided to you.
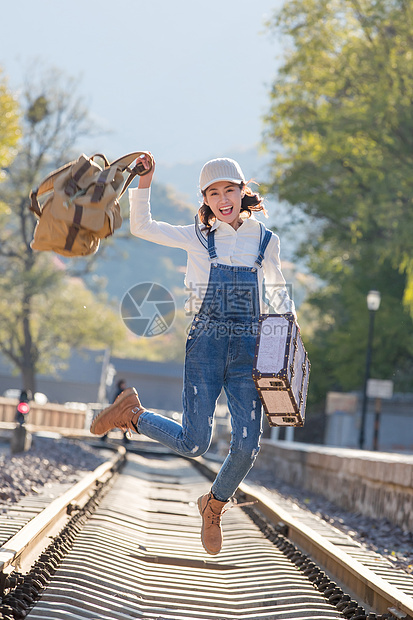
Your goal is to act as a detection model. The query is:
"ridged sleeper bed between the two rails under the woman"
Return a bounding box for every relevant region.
[24,452,342,620]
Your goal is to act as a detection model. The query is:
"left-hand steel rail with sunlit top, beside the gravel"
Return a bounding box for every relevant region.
[0,446,126,582]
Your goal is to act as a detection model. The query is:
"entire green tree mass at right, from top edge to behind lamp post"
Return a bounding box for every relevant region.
[266,0,413,416]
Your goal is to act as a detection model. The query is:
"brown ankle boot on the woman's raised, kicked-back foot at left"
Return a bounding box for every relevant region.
[90,388,145,435]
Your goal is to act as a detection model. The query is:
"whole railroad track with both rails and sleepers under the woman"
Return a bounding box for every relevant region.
[0,440,413,620]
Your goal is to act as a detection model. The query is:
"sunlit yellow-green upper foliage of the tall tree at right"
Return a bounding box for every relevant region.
[267,0,413,309]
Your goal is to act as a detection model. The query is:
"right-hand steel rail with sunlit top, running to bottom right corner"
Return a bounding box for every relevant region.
[196,457,413,620]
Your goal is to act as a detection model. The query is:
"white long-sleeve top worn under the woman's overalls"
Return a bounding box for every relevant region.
[129,188,295,315]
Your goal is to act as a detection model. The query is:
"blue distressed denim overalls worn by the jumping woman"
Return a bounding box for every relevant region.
[138,223,272,501]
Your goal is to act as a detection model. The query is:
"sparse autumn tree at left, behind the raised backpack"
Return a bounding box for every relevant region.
[0,71,123,392]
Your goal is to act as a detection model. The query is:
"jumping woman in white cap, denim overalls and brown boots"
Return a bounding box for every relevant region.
[90,155,295,555]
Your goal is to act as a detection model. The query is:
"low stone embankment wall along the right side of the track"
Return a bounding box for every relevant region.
[254,439,413,532]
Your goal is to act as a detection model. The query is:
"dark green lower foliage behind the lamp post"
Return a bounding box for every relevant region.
[302,248,413,403]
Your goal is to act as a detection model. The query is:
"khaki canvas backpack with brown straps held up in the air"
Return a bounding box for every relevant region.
[30,151,149,256]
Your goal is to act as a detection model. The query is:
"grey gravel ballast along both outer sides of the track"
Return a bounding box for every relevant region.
[0,436,413,573]
